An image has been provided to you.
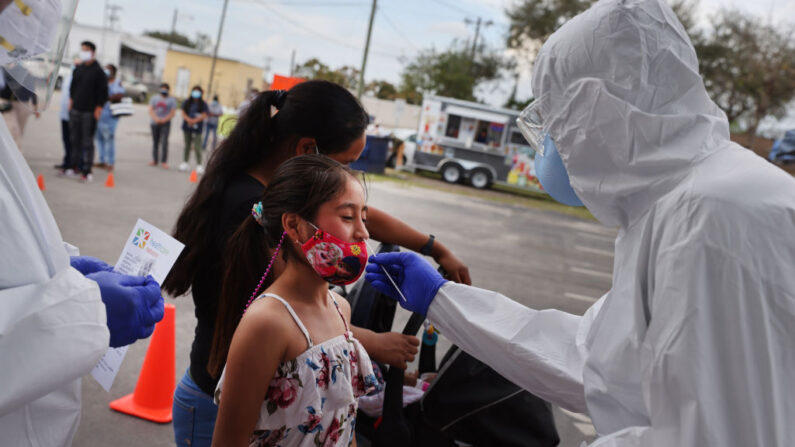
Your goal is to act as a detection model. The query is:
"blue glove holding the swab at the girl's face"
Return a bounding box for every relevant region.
[365,252,447,316]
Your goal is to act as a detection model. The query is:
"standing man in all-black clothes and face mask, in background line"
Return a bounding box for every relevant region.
[62,40,108,183]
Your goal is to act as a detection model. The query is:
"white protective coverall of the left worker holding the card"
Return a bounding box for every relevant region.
[0,117,110,447]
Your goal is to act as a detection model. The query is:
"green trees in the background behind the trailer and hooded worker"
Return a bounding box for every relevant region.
[296,0,795,135]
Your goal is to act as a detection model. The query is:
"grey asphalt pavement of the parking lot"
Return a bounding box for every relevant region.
[21,93,615,447]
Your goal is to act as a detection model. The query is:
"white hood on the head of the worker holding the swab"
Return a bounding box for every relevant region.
[533,0,729,226]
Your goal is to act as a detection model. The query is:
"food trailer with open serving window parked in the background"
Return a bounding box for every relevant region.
[409,96,540,190]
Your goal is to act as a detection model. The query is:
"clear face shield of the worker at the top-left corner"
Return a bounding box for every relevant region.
[0,0,78,110]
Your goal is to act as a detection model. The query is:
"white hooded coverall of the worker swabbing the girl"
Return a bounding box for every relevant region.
[428,0,795,447]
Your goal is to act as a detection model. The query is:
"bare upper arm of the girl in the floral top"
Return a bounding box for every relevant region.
[213,302,293,447]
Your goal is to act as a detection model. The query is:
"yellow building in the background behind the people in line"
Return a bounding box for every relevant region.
[163,46,263,108]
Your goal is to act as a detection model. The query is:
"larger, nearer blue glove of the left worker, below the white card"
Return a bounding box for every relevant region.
[86,272,163,348]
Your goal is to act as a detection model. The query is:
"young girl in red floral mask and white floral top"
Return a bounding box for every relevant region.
[210,155,377,446]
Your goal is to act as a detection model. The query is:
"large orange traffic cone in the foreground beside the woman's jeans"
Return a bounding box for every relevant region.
[110,304,176,423]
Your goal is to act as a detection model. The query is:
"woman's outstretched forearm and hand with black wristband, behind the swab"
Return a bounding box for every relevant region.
[367,207,472,285]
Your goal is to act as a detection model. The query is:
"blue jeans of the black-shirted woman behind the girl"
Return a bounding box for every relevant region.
[172,368,218,447]
